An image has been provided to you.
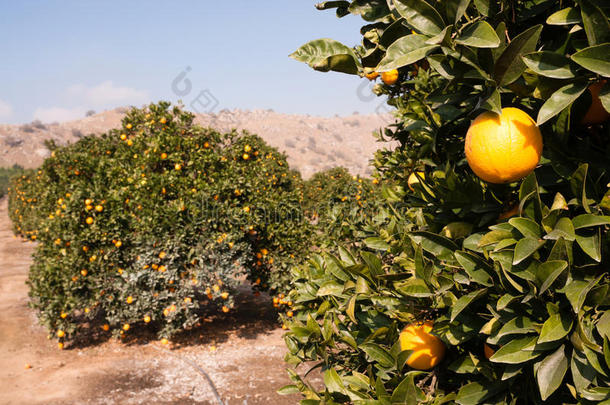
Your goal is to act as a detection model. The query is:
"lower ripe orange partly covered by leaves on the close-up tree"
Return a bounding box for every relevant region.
[399,321,446,370]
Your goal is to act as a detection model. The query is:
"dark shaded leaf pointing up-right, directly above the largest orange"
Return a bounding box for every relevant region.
[493,25,542,86]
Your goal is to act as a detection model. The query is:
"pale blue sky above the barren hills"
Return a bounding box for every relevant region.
[0,0,380,123]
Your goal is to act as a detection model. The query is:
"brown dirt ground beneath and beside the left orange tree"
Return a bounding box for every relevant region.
[0,199,319,405]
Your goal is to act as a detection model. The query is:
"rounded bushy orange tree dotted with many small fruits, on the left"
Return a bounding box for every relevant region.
[10,102,311,347]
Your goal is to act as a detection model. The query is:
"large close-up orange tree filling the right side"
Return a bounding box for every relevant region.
[281,0,610,404]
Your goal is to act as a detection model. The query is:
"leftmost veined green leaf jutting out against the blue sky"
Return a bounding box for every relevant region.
[290,38,361,75]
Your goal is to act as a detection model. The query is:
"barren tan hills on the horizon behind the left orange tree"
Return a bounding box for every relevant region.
[0,108,391,177]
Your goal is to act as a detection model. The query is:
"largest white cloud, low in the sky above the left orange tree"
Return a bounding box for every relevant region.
[67,80,149,108]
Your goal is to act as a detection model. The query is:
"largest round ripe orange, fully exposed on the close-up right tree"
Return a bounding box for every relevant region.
[464,107,542,184]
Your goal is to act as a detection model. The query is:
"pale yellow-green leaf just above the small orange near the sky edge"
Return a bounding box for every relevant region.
[375,34,439,72]
